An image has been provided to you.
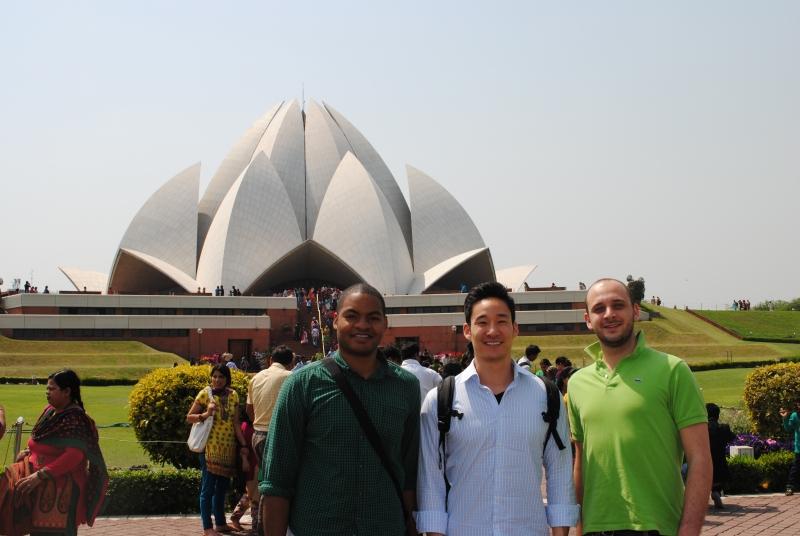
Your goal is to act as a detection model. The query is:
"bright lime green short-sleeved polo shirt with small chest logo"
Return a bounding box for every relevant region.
[569,333,707,536]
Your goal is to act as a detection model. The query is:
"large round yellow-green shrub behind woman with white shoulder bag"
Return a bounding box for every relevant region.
[128,365,249,469]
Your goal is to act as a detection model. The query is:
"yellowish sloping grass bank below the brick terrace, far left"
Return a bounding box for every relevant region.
[0,336,184,380]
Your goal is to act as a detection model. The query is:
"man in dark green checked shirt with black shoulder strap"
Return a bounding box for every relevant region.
[259,284,420,536]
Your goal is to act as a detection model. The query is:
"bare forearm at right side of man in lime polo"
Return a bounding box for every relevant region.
[678,423,712,536]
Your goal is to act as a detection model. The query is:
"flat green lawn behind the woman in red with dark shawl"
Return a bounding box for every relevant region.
[0,385,150,468]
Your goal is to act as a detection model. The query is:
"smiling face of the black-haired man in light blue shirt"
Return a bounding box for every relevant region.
[464,298,519,362]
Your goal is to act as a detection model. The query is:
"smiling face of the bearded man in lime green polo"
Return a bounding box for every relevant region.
[583,280,639,348]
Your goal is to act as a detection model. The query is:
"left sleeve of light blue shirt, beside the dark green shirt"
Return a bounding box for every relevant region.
[415,389,447,534]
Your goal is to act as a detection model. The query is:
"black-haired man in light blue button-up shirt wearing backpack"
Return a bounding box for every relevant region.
[416,283,580,536]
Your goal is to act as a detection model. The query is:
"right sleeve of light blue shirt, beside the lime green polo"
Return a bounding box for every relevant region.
[544,401,581,527]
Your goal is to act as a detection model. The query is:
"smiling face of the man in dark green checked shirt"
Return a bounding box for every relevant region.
[333,292,388,357]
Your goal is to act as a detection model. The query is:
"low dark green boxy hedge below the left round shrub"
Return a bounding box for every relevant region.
[102,469,200,516]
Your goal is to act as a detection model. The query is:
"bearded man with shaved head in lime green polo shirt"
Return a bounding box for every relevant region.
[569,279,711,536]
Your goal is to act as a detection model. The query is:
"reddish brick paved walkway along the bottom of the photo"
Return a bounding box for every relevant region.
[78,494,800,536]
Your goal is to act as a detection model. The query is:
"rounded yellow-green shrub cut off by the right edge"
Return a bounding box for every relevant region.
[744,363,800,437]
